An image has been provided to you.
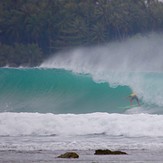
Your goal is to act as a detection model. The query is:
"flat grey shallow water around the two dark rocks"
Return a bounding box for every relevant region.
[0,149,163,163]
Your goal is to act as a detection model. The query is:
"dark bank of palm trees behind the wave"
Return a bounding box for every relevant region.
[0,0,163,66]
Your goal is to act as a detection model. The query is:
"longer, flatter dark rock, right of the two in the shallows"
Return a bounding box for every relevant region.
[94,149,127,155]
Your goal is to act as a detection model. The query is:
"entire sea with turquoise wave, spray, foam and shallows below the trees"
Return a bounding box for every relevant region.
[0,34,163,162]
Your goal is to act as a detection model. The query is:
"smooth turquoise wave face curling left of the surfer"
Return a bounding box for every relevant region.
[0,68,131,113]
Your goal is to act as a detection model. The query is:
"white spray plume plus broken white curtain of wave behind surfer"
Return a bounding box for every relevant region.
[40,33,163,110]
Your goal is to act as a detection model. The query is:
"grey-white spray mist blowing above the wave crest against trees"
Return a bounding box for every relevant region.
[41,33,163,72]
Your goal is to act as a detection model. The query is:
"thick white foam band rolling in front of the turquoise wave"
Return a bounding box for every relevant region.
[0,113,163,137]
